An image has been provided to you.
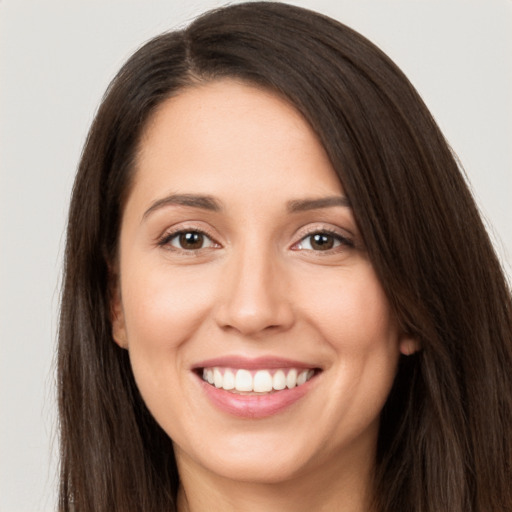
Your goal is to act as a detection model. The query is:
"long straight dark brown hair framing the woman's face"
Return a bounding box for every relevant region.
[58,2,512,512]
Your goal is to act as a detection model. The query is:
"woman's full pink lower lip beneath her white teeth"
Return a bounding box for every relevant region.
[199,377,315,419]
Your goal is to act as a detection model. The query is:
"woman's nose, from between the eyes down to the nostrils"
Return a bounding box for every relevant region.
[216,243,294,337]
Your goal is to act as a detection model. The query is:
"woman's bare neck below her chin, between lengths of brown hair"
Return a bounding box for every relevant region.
[178,444,373,512]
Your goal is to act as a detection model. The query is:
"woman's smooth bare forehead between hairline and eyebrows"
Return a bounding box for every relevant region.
[135,79,342,203]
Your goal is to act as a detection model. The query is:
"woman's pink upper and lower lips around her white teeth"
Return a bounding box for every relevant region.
[192,356,318,419]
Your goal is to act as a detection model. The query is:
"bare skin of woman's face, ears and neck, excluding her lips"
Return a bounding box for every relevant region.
[112,80,414,512]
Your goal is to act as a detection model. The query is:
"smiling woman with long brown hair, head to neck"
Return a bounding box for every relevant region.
[59,2,512,512]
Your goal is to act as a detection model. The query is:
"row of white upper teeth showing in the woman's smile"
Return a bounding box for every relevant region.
[203,368,315,393]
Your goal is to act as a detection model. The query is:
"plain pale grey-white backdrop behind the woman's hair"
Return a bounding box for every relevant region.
[0,0,512,512]
